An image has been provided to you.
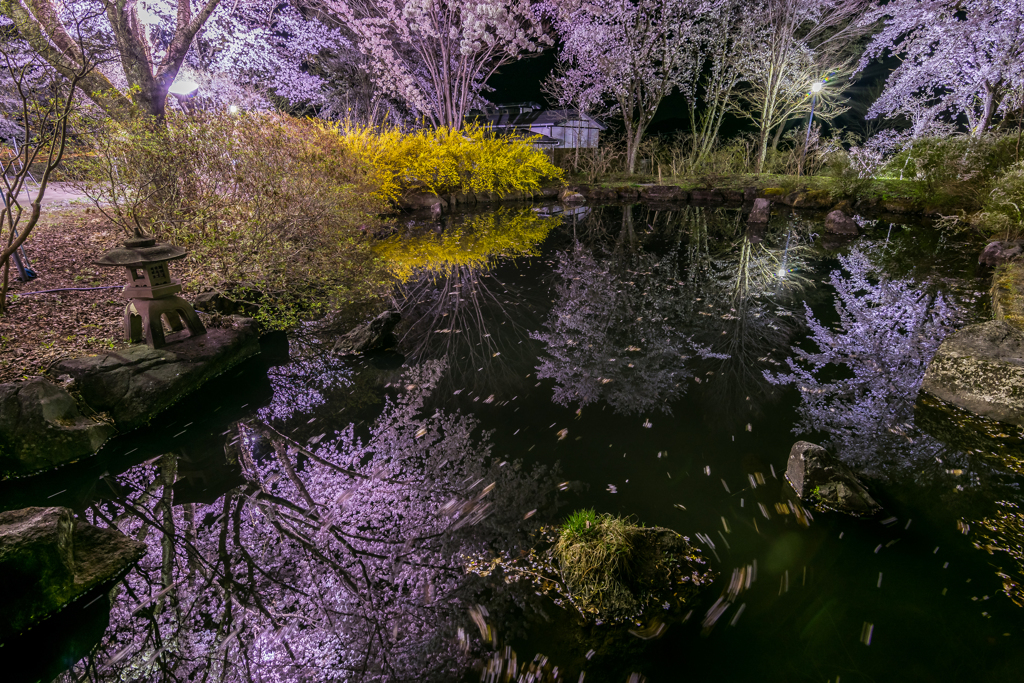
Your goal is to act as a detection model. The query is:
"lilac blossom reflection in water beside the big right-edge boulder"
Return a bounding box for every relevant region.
[766,250,962,473]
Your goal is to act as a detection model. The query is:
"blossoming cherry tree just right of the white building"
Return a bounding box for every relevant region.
[556,0,719,173]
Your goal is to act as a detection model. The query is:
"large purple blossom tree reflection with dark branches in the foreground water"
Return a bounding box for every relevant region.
[59,362,555,681]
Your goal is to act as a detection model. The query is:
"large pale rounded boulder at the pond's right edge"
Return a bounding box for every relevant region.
[921,321,1024,425]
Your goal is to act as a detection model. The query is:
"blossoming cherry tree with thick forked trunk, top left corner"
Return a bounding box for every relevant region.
[0,0,344,121]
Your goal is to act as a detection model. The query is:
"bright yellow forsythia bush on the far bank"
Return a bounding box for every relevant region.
[337,124,562,201]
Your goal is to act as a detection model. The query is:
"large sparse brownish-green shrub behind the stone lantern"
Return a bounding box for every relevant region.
[69,113,386,329]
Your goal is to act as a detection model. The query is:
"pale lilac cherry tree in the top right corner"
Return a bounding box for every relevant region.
[860,0,1024,137]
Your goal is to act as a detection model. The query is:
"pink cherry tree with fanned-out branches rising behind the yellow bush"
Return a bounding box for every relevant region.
[325,0,553,128]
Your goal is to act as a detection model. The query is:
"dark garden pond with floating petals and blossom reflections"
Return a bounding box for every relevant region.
[0,200,1024,683]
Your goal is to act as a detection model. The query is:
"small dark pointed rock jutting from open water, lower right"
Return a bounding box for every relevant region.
[785,441,882,517]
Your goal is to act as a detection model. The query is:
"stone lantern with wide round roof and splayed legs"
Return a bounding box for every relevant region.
[95,238,206,348]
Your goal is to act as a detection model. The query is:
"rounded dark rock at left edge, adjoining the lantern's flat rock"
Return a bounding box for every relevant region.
[0,377,117,479]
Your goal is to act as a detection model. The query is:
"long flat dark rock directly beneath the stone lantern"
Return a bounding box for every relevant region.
[55,316,259,432]
